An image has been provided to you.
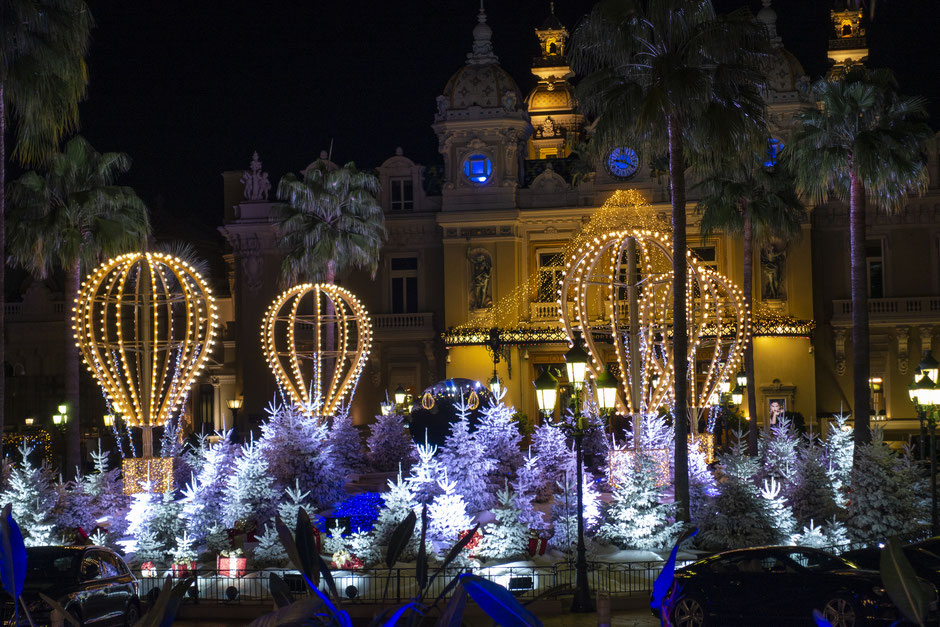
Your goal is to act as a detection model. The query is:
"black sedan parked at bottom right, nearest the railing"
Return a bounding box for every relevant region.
[654,546,936,627]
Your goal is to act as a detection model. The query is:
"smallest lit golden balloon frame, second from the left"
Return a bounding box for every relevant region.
[261,283,372,416]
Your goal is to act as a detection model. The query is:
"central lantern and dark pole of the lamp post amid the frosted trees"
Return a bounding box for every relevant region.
[565,333,594,612]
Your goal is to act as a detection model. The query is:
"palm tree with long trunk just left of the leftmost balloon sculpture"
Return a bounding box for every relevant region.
[8,135,150,473]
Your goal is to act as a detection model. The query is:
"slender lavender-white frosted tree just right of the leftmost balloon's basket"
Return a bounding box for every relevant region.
[182,431,239,544]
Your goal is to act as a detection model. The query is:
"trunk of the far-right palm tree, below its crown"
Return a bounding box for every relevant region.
[849,171,871,446]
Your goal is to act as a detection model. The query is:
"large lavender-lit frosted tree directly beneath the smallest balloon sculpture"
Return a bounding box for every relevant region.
[257,405,345,509]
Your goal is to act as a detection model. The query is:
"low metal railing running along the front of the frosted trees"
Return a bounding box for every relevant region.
[137,562,689,605]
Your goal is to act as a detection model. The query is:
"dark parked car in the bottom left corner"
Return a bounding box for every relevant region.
[0,546,140,626]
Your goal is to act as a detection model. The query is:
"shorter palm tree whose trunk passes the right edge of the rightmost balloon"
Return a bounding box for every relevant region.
[698,154,806,456]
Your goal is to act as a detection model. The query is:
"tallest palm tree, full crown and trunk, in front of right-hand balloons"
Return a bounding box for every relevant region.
[572,0,769,521]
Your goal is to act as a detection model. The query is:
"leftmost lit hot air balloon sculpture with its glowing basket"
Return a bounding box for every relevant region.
[74,252,217,494]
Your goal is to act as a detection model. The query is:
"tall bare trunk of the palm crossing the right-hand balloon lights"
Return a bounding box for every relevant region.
[669,115,697,522]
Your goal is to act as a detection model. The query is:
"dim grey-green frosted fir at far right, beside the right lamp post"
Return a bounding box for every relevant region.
[846,429,927,542]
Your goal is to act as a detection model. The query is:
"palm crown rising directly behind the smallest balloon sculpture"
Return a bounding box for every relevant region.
[273,159,385,283]
